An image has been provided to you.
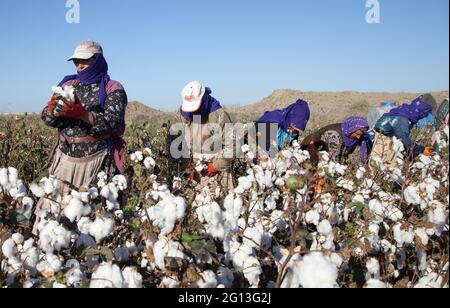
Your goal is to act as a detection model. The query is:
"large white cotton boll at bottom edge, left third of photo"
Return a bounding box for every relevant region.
[89,263,124,289]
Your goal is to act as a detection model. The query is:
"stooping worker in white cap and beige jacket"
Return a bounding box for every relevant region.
[180,81,235,194]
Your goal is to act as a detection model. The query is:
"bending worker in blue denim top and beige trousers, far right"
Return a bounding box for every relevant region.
[372,97,432,169]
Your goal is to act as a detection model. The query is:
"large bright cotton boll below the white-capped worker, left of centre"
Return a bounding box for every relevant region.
[148,194,186,235]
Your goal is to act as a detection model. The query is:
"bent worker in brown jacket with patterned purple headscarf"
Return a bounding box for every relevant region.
[302,116,373,168]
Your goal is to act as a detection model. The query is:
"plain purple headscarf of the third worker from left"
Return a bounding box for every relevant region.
[258,99,311,131]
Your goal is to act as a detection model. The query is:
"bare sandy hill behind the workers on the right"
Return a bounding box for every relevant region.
[227,89,449,129]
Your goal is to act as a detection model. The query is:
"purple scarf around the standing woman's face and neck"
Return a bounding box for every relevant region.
[59,53,111,107]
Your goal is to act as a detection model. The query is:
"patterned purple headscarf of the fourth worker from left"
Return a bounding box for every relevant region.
[342,116,370,163]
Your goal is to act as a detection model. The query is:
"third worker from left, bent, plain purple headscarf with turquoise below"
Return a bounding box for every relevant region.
[256,99,311,149]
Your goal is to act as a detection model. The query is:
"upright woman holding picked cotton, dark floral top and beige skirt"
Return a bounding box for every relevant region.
[34,41,128,231]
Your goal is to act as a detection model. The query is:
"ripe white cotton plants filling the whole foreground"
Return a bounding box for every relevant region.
[0,121,449,288]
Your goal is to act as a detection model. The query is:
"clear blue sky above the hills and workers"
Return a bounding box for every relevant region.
[0,0,449,112]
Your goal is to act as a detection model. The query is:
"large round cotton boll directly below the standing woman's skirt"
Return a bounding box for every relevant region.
[39,221,72,254]
